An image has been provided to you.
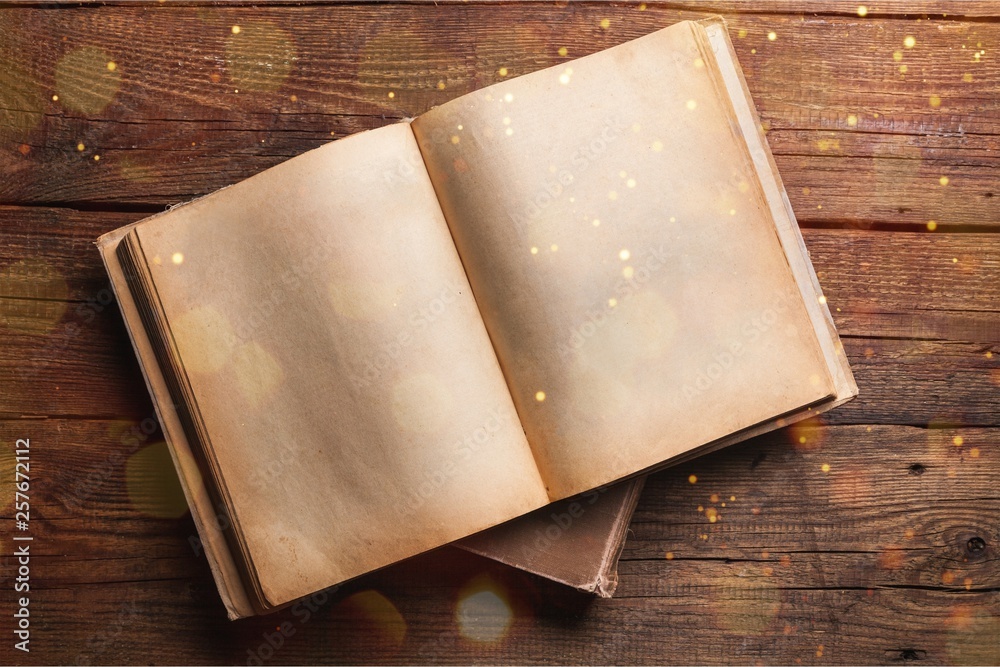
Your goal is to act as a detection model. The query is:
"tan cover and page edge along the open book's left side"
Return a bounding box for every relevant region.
[97,226,257,620]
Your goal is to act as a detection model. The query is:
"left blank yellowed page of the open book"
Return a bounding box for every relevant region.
[128,124,547,605]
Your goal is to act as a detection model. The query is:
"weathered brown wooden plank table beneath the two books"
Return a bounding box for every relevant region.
[0,0,1000,664]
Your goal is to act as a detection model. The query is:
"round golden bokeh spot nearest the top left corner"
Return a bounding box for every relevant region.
[55,46,121,115]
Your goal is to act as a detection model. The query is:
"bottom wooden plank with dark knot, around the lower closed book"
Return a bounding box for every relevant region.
[0,420,1000,664]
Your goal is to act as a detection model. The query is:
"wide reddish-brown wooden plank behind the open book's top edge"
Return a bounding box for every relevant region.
[0,3,1000,228]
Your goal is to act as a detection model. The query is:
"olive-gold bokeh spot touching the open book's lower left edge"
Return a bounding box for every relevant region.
[125,442,197,519]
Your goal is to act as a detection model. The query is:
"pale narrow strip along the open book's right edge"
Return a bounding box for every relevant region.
[696,16,858,402]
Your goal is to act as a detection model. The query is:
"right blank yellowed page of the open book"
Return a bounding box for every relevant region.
[413,22,834,499]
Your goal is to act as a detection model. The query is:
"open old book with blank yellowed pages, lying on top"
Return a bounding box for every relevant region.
[99,21,857,617]
